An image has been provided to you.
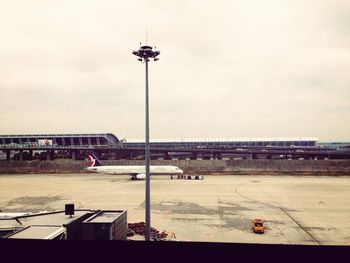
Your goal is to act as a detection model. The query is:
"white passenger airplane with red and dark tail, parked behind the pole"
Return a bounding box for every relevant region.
[86,154,183,180]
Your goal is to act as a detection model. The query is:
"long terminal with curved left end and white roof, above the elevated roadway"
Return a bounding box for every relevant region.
[0,133,317,148]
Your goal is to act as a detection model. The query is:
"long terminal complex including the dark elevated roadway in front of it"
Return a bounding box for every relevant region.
[0,133,350,161]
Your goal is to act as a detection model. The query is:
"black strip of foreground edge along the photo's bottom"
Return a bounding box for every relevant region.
[0,239,350,263]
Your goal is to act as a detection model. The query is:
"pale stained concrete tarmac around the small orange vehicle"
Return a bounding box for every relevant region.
[0,174,350,246]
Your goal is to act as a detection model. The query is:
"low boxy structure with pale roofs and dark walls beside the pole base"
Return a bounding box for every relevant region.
[0,209,128,240]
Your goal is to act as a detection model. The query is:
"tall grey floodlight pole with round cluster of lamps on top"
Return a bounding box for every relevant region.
[132,46,160,241]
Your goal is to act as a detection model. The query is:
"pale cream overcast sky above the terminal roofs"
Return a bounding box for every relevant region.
[0,0,350,141]
